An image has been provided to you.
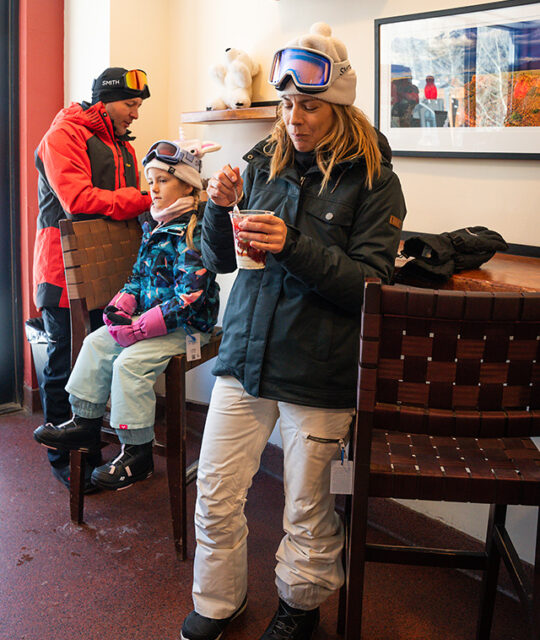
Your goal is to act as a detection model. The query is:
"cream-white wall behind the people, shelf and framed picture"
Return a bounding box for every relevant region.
[66,0,540,562]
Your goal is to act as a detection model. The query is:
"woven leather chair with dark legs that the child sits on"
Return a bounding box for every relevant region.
[60,219,221,559]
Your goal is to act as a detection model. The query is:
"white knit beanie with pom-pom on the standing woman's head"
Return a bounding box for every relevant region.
[278,22,356,104]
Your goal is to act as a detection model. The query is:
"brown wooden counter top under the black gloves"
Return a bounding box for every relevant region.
[396,253,540,291]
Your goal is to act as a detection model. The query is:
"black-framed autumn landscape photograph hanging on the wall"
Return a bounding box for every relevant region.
[375,0,540,159]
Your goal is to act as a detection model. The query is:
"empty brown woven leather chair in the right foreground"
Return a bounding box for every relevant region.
[338,282,540,640]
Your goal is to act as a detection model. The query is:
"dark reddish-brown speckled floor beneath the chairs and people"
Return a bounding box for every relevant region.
[0,412,525,640]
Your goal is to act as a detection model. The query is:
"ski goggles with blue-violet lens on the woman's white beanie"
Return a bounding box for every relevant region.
[269,47,351,93]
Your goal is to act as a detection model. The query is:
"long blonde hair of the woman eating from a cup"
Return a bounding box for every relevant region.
[264,102,381,193]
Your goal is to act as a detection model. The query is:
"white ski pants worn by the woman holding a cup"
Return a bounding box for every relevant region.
[193,376,354,618]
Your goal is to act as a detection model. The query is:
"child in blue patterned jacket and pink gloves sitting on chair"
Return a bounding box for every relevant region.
[34,140,220,489]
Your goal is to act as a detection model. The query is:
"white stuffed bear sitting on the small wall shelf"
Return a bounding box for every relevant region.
[206,48,260,110]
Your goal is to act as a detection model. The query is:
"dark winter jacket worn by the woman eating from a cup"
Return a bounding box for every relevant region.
[202,141,405,408]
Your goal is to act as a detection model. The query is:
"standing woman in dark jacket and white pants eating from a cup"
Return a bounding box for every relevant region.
[181,24,405,640]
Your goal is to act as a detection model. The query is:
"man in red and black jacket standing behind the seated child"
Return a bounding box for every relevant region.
[34,67,151,486]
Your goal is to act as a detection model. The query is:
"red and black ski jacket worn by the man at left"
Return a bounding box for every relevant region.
[34,102,151,309]
